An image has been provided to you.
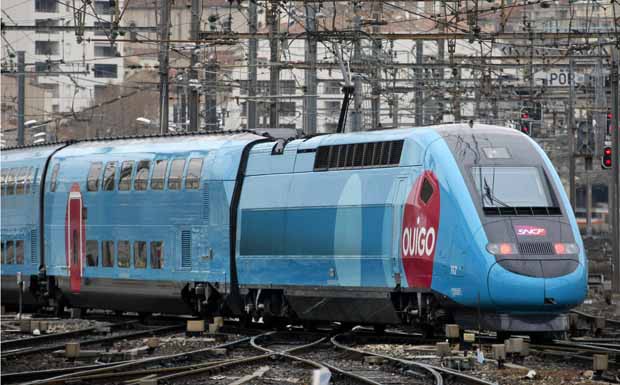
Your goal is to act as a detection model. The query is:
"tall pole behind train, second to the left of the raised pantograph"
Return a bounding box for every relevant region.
[268,0,280,128]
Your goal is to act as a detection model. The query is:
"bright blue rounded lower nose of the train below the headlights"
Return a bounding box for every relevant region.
[488,260,585,310]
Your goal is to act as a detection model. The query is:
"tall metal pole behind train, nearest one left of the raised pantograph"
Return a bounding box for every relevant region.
[303,3,317,135]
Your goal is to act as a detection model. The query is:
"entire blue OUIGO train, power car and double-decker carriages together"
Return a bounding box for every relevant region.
[1,124,587,332]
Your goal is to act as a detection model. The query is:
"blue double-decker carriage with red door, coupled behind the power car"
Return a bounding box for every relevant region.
[45,133,264,313]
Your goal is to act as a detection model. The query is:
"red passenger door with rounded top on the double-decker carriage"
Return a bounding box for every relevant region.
[65,183,86,293]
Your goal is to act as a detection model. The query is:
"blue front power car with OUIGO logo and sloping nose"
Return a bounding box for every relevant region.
[236,125,587,331]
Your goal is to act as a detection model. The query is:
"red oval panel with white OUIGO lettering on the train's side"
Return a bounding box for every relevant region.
[400,171,440,288]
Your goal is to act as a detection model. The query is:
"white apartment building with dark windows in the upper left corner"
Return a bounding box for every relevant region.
[2,0,124,117]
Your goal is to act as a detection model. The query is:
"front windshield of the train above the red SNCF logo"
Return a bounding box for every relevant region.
[472,167,553,207]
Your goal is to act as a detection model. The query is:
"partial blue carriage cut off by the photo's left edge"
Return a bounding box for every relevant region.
[0,145,62,306]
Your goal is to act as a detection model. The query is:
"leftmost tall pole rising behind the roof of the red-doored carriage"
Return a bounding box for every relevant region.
[159,0,170,135]
